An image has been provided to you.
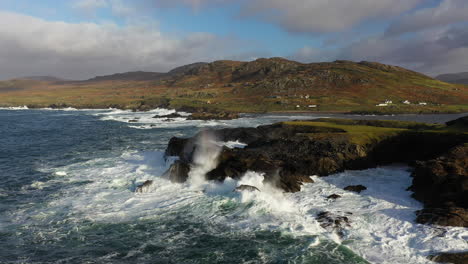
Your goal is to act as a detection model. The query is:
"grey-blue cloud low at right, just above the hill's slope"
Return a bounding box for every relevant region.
[334,27,468,75]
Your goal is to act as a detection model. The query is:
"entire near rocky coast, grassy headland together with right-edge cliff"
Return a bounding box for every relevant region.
[165,117,468,231]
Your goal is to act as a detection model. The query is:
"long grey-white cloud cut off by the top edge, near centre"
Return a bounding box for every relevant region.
[98,0,424,33]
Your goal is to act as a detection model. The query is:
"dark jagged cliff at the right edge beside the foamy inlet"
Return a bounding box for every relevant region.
[411,144,468,227]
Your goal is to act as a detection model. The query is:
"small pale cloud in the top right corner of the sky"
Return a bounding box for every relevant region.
[387,0,468,35]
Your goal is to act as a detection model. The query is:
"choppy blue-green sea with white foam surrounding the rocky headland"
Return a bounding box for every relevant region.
[0,109,468,263]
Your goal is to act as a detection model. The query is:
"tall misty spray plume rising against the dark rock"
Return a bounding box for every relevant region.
[189,130,221,186]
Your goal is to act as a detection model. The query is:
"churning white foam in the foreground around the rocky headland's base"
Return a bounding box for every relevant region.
[12,147,468,264]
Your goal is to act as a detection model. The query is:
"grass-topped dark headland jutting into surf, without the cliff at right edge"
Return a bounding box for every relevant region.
[166,119,467,195]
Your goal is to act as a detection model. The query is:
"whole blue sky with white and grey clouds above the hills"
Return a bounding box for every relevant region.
[0,0,468,79]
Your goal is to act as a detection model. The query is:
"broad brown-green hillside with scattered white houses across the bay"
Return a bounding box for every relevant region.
[0,58,468,113]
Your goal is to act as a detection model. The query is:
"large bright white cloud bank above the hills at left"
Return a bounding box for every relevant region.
[0,11,249,79]
